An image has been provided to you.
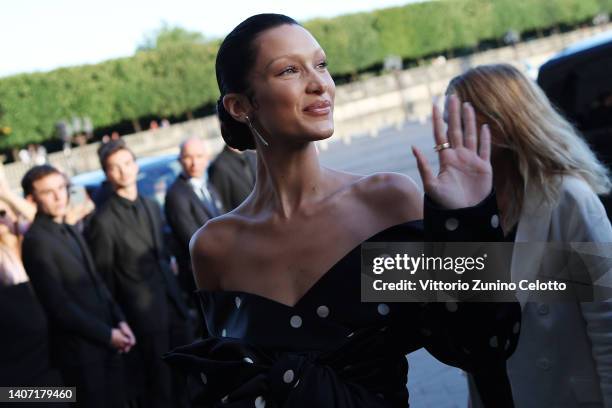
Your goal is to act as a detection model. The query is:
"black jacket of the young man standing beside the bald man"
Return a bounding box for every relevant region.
[86,194,188,334]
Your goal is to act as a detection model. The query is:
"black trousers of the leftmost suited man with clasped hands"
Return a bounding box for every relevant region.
[60,354,125,408]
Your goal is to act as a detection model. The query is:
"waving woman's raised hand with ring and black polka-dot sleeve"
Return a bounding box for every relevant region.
[413,95,521,407]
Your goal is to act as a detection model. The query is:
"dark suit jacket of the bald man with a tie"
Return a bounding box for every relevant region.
[164,174,224,284]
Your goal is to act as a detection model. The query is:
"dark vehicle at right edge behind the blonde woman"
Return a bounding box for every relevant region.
[538,31,612,219]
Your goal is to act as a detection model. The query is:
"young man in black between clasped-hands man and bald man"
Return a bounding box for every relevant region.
[87,141,191,407]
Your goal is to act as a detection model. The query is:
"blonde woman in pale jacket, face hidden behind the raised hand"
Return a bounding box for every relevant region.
[447,65,612,408]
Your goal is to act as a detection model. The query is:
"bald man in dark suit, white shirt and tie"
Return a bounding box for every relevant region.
[164,137,224,293]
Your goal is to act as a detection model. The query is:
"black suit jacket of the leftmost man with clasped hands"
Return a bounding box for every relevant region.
[23,214,125,365]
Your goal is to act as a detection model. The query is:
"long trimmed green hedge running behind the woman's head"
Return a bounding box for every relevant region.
[0,0,612,148]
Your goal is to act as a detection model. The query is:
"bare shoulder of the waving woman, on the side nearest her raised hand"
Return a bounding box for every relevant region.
[355,172,423,223]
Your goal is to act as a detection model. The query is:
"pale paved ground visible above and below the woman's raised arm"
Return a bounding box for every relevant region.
[321,119,467,408]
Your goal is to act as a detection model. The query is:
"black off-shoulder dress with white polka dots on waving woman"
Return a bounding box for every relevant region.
[164,195,520,408]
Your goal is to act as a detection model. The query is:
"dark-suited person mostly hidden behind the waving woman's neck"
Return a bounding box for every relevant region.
[208,145,257,211]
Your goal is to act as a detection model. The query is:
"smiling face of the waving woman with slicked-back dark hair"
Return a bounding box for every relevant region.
[249,25,335,144]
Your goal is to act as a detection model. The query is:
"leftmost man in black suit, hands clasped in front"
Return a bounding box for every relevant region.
[21,165,135,407]
